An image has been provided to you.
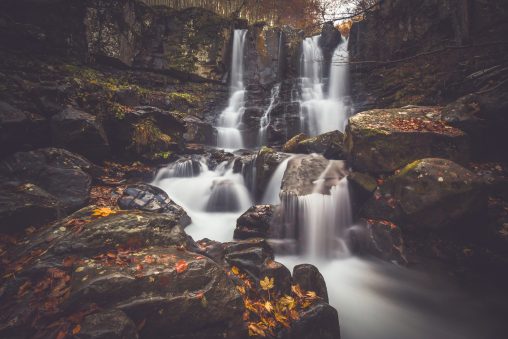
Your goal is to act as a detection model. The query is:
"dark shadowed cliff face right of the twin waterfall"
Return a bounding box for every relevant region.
[349,0,508,110]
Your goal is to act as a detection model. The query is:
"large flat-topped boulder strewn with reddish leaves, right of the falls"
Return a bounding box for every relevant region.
[345,106,470,173]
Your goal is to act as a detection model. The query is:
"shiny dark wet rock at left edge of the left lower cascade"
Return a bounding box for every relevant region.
[118,184,191,227]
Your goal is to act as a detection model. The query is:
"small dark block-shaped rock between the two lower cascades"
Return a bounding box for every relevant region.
[233,205,276,240]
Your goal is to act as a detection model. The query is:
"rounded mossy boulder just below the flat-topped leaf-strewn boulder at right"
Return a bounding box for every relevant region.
[363,158,486,231]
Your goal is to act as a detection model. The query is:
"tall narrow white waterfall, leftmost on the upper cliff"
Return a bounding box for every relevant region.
[216,29,247,149]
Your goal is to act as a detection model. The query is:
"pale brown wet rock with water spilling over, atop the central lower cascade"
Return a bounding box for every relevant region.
[281,154,329,196]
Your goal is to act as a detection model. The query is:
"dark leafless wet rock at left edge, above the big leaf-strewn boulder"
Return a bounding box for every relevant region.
[0,148,98,212]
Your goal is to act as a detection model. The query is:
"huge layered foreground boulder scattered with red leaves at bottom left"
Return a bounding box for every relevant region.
[0,207,243,338]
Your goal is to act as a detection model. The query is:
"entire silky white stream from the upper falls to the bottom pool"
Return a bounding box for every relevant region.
[153,30,500,339]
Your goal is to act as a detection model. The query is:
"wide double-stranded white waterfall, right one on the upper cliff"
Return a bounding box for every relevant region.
[300,36,349,135]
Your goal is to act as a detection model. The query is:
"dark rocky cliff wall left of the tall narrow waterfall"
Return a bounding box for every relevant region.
[0,0,234,80]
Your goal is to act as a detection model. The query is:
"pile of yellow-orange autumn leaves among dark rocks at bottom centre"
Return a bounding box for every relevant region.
[228,266,320,338]
